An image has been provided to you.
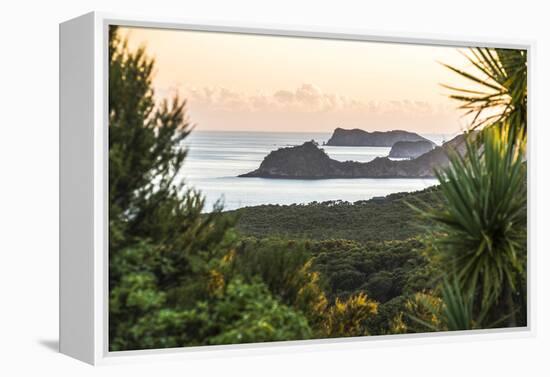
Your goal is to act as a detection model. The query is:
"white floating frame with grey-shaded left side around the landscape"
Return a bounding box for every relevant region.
[59,12,536,364]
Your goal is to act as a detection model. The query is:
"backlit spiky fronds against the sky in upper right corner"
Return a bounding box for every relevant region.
[443,47,527,131]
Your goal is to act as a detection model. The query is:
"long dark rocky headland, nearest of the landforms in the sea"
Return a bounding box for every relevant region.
[239,135,464,179]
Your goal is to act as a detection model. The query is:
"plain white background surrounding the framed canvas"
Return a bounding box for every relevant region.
[0,0,550,376]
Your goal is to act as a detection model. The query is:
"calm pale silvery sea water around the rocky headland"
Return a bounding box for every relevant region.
[181,131,445,211]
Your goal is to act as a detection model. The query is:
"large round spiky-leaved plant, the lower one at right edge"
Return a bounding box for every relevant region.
[423,125,527,325]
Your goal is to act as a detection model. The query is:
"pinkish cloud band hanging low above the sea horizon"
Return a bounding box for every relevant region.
[157,83,466,130]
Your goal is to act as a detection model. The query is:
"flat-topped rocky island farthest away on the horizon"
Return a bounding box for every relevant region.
[326,128,429,147]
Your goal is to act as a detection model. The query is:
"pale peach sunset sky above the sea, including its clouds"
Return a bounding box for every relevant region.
[120,27,478,134]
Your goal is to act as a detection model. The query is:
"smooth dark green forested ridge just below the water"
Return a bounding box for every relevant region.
[229,187,442,241]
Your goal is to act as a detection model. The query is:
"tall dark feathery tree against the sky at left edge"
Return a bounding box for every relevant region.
[109,27,236,284]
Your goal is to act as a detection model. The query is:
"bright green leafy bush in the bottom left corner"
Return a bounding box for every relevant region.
[111,276,311,350]
